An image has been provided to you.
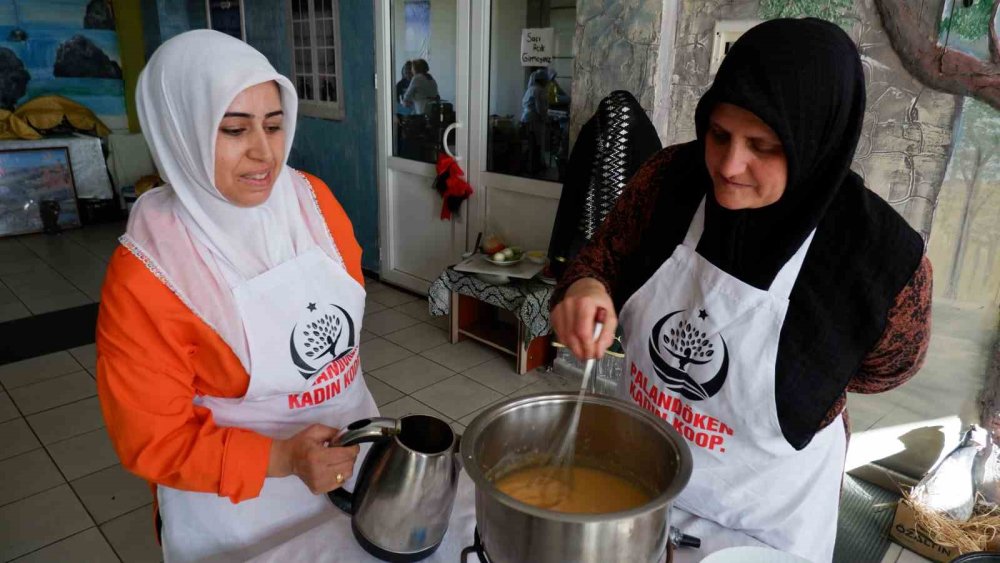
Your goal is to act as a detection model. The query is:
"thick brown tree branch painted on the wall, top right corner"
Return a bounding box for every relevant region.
[875,0,1000,109]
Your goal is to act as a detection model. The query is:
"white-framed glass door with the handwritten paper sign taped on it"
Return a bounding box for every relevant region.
[469,0,576,256]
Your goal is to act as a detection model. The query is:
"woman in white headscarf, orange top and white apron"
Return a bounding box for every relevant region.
[97,30,378,561]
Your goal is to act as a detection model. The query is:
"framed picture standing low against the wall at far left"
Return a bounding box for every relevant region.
[0,147,80,237]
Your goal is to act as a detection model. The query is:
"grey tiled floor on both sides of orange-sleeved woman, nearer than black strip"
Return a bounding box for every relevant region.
[0,272,579,562]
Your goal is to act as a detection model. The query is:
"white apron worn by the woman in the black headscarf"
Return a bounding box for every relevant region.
[619,200,847,562]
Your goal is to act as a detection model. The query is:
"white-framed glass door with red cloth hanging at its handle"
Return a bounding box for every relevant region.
[375,0,470,292]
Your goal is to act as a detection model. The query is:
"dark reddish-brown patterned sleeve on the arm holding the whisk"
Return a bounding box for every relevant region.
[550,147,675,307]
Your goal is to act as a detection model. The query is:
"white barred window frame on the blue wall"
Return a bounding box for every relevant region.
[285,0,345,121]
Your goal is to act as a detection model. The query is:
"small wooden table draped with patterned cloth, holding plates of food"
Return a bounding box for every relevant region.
[428,268,555,375]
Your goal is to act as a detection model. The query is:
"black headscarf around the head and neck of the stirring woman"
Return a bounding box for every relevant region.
[695,19,865,289]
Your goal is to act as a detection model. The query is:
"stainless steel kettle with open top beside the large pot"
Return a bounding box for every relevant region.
[329,414,460,561]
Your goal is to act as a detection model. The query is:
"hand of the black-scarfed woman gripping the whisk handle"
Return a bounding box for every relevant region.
[551,278,618,359]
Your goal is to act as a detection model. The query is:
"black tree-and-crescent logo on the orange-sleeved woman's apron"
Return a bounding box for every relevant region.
[289,303,356,380]
